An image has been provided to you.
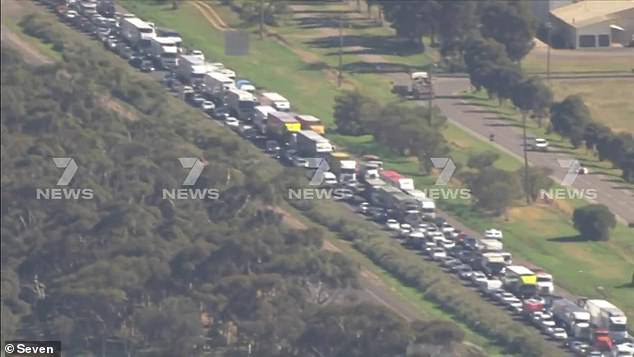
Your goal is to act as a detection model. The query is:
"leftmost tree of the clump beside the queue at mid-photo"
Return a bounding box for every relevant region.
[334,91,379,135]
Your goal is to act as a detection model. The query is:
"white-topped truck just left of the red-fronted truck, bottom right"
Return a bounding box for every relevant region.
[550,298,592,341]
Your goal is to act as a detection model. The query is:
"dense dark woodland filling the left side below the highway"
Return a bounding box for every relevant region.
[0,16,474,356]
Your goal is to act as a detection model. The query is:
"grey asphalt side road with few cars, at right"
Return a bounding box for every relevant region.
[430,78,634,223]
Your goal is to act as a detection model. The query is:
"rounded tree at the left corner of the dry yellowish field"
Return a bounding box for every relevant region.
[550,95,592,148]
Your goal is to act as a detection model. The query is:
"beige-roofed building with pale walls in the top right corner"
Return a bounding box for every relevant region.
[550,0,634,48]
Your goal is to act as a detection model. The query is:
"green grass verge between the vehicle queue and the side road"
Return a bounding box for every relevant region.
[119,1,634,326]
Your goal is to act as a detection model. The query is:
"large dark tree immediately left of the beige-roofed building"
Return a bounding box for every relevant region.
[480,1,536,62]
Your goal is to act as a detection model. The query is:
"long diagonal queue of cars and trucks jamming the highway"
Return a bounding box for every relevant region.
[50,0,634,357]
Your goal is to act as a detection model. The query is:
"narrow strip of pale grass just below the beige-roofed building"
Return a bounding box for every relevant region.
[522,45,634,73]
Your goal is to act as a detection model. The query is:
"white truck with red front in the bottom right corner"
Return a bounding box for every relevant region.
[579,299,629,342]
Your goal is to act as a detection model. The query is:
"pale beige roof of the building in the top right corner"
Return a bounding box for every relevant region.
[550,0,634,28]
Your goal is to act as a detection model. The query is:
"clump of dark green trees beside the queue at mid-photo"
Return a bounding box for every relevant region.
[334,91,449,172]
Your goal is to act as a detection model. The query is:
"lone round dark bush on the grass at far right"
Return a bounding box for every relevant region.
[572,204,616,241]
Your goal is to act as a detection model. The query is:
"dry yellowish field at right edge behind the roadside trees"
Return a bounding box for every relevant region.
[551,78,634,133]
